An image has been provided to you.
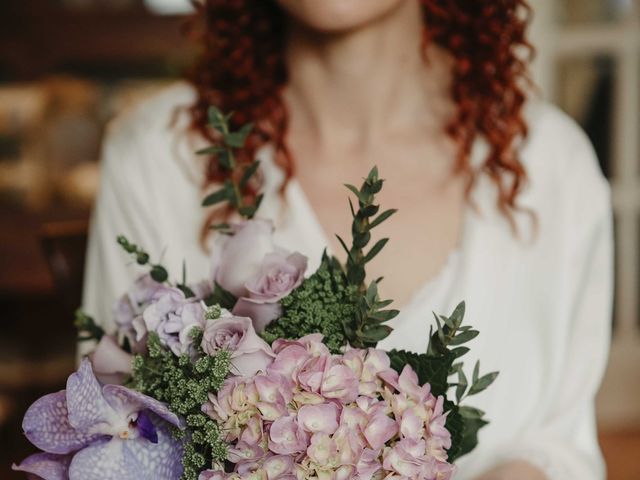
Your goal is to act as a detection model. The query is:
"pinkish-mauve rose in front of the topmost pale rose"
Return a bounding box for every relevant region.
[233,249,307,332]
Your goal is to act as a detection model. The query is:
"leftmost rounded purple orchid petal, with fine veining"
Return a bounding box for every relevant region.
[22,390,100,454]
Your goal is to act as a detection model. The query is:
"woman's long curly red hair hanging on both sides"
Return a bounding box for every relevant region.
[188,0,532,240]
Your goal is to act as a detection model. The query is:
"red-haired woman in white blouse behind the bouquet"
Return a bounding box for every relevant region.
[85,0,612,480]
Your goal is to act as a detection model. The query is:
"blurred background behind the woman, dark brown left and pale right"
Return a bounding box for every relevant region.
[0,0,640,480]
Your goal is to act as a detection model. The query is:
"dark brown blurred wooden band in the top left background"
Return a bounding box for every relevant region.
[0,0,189,81]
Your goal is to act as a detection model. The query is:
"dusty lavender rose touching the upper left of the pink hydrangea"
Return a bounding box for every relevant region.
[202,316,275,377]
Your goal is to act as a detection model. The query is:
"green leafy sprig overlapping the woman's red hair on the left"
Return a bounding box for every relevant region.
[196,106,263,219]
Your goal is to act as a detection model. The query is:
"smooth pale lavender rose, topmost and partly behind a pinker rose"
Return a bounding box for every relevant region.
[214,219,276,297]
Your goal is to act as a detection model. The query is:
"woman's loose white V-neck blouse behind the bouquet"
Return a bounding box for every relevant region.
[84,80,612,480]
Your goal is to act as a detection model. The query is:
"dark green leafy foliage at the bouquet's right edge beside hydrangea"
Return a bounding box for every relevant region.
[389,302,498,462]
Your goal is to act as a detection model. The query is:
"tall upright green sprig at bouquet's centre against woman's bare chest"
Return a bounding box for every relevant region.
[336,167,399,348]
